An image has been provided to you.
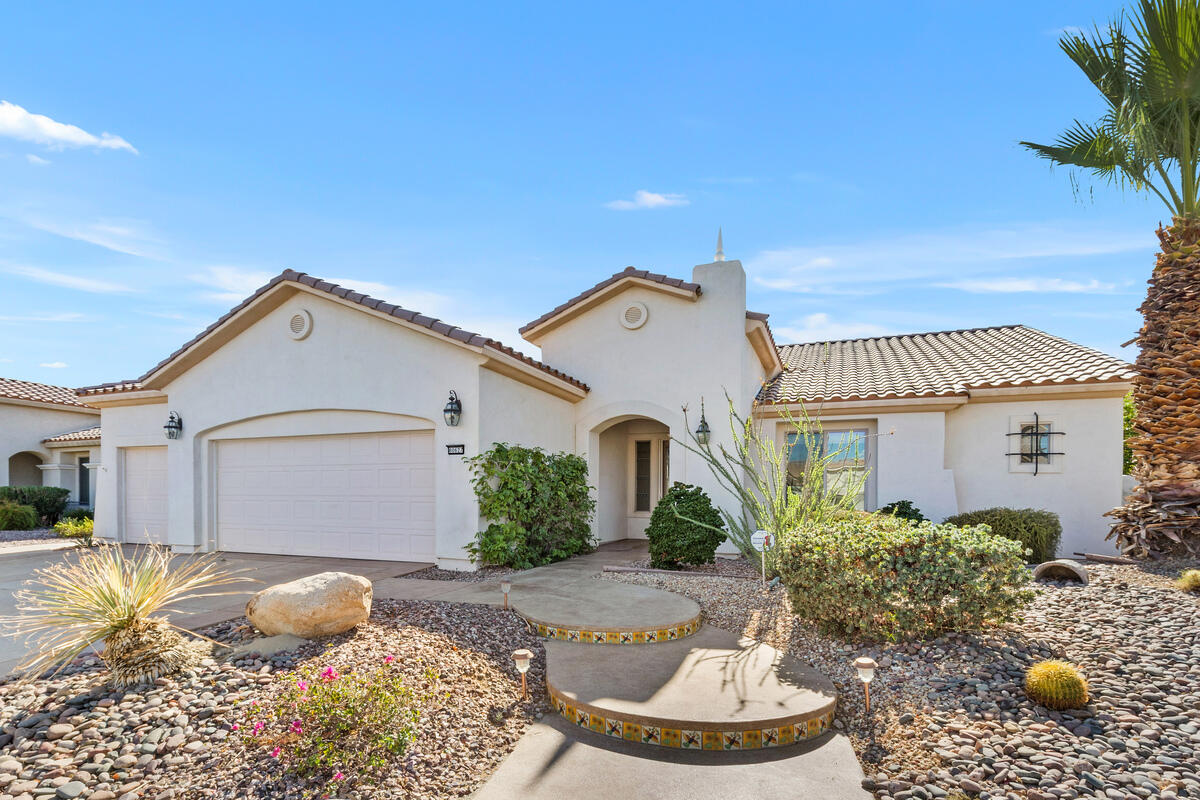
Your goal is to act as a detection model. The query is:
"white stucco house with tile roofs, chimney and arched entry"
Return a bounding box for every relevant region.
[79,255,1132,569]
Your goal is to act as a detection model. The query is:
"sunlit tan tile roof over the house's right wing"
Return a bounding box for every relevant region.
[760,325,1135,403]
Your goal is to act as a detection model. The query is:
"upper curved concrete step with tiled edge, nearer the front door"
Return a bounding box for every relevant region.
[509,581,700,644]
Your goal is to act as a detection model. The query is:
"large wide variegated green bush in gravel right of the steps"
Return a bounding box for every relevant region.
[779,515,1033,640]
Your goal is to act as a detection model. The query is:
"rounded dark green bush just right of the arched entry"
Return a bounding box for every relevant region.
[646,483,725,570]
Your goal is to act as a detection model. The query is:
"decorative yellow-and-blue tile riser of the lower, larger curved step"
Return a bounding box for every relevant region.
[546,686,835,751]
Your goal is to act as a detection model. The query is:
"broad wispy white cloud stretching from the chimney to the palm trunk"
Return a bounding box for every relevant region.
[745,223,1154,294]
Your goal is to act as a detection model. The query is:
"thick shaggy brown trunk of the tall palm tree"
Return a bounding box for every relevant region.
[1109,217,1200,555]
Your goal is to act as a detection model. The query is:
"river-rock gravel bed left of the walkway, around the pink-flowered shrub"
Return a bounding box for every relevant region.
[0,600,545,800]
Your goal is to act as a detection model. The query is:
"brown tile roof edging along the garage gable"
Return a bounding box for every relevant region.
[79,270,589,395]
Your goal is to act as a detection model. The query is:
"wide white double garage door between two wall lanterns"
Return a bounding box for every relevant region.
[216,431,436,561]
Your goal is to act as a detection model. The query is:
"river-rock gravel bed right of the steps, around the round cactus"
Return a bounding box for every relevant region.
[604,561,1200,800]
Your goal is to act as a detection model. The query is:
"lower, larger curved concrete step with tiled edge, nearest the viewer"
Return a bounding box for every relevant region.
[546,626,838,750]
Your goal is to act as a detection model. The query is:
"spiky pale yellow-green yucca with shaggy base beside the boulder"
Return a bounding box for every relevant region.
[6,545,250,686]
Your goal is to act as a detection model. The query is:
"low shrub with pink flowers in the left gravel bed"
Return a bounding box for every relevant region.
[239,656,438,786]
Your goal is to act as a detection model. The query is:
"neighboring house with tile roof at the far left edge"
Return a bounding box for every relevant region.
[0,378,100,506]
